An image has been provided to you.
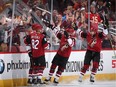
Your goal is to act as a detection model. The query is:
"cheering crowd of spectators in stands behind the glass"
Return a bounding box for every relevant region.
[0,0,116,52]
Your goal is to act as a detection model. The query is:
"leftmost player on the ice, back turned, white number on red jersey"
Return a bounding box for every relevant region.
[24,24,48,84]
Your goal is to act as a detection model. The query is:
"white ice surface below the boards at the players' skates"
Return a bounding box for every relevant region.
[18,81,116,87]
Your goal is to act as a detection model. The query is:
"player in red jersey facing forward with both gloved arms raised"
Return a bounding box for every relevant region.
[77,25,108,82]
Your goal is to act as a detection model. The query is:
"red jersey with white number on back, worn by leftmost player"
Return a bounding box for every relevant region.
[24,32,48,58]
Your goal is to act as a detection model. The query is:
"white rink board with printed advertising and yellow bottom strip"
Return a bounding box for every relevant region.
[0,50,116,87]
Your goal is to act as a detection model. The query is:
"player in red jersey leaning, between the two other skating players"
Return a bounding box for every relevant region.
[44,29,74,84]
